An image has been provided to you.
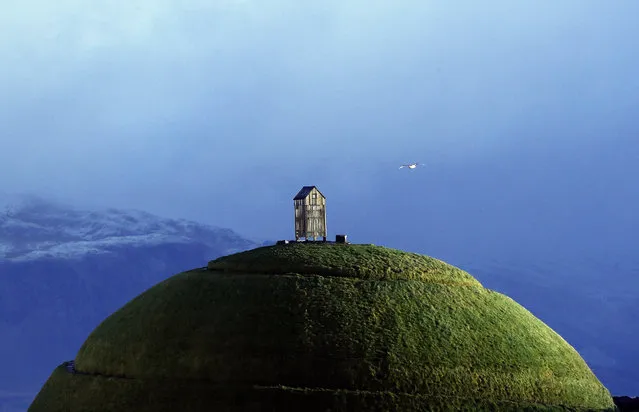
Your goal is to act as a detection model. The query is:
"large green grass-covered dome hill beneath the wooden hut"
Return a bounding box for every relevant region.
[29,243,615,412]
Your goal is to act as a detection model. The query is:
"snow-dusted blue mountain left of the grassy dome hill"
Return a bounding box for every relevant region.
[0,196,261,395]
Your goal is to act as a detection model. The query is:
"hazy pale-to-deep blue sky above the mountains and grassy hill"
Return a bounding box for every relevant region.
[0,0,639,257]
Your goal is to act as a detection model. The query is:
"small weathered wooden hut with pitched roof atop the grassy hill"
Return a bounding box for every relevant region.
[293,186,327,241]
